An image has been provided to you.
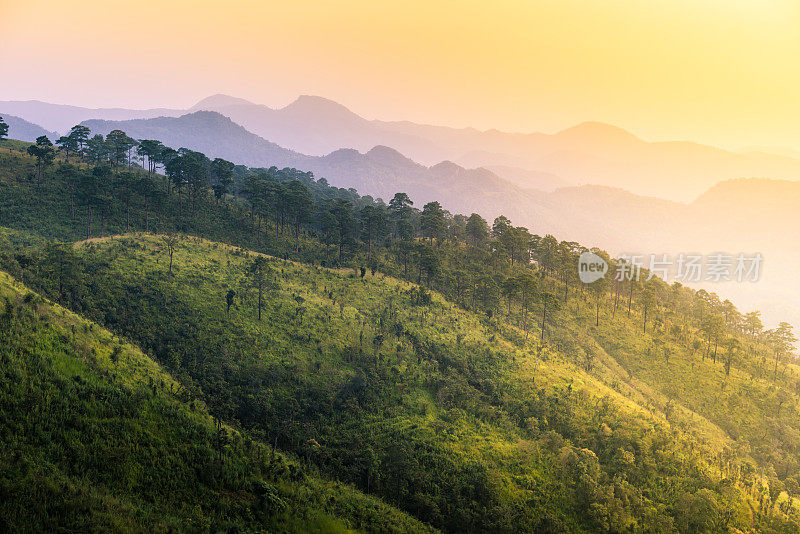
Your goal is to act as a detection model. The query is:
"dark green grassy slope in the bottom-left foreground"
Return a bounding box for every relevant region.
[0,273,438,532]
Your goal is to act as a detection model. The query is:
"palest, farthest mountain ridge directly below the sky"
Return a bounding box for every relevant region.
[6,94,800,201]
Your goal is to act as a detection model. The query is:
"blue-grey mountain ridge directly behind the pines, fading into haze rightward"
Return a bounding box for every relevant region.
[83,111,544,224]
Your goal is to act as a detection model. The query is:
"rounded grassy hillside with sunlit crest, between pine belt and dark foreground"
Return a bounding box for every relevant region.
[3,236,797,531]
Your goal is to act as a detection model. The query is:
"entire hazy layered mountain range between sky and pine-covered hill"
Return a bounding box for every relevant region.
[0,95,800,330]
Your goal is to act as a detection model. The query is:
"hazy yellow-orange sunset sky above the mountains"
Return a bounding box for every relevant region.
[0,0,800,149]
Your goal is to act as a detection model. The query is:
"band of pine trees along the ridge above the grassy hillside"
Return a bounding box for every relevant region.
[0,121,796,377]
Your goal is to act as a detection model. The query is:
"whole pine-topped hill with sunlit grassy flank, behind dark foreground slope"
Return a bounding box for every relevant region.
[0,133,800,532]
